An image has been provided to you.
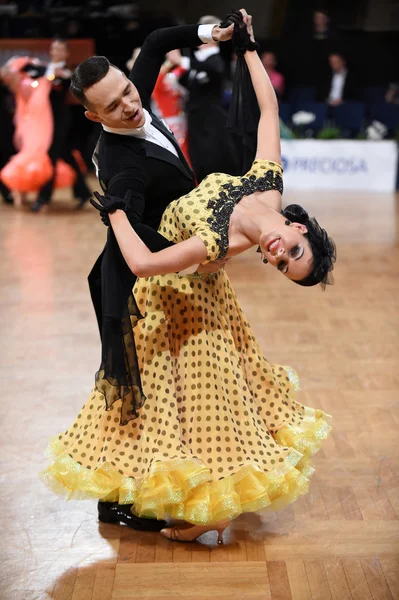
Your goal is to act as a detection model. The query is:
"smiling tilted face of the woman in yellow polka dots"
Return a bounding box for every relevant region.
[259,223,313,281]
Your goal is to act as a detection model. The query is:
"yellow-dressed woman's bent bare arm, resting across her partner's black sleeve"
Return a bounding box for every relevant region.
[109,210,207,277]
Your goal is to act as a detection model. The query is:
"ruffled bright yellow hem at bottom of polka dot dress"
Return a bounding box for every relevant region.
[42,409,331,525]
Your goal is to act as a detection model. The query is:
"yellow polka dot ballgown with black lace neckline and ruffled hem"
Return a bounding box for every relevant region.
[44,160,330,524]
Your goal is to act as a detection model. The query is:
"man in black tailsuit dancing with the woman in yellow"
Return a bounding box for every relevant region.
[70,25,232,531]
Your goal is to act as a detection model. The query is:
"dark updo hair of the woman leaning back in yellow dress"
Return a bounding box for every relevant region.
[282,204,337,289]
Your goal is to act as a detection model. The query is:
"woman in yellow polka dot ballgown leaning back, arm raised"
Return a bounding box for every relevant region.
[45,13,335,542]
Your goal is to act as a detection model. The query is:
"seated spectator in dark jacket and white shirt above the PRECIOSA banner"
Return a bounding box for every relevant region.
[317,53,360,106]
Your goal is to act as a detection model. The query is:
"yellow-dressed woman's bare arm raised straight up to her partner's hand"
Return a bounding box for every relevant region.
[243,14,281,163]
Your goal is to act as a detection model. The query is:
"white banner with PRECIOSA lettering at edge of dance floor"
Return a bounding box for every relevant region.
[281,140,398,192]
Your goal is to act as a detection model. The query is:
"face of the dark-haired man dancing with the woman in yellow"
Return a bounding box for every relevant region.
[85,67,145,129]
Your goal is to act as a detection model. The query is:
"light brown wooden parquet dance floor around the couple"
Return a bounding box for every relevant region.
[0,180,399,600]
